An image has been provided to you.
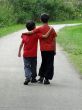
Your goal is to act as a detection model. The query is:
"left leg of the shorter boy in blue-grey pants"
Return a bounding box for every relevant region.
[24,58,32,80]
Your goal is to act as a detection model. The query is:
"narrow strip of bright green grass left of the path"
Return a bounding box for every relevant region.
[0,24,25,37]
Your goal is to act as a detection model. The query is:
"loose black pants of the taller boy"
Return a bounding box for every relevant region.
[39,51,54,80]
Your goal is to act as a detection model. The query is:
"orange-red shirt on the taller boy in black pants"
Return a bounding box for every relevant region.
[34,24,57,51]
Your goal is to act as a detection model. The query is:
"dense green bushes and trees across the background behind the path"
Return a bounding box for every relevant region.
[0,0,82,27]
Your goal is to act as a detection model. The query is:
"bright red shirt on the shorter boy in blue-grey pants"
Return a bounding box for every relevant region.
[21,33,42,57]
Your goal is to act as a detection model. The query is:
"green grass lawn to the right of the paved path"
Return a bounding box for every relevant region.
[57,25,82,74]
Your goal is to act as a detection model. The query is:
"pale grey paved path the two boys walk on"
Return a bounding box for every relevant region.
[0,25,82,110]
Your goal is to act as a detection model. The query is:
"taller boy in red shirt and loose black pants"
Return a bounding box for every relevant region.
[29,13,57,84]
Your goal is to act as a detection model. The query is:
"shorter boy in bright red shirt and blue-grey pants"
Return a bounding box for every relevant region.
[18,21,51,85]
